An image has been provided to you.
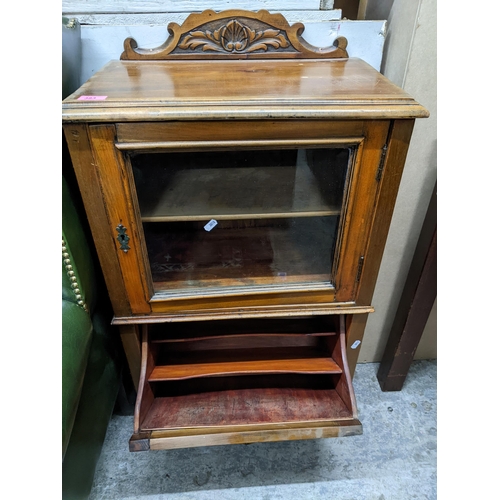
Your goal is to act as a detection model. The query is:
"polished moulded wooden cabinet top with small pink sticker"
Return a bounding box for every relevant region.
[63,58,428,122]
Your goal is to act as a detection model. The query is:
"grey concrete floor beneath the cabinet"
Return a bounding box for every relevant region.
[90,361,437,500]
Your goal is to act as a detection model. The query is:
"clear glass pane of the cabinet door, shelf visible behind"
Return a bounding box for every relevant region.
[130,148,352,292]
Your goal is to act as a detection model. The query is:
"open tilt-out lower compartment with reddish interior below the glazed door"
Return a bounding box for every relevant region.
[130,316,361,451]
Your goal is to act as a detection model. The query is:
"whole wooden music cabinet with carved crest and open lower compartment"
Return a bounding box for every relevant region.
[63,10,428,451]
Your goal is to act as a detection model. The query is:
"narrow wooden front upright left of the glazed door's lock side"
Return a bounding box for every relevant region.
[64,124,130,316]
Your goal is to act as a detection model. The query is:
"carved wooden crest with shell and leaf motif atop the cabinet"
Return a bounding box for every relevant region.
[120,10,349,60]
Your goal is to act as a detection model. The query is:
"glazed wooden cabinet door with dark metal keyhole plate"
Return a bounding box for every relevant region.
[64,121,389,314]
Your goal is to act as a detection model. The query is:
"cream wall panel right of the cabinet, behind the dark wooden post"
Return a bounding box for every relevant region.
[359,0,437,363]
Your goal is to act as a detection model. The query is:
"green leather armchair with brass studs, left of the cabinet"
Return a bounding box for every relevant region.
[62,19,122,500]
